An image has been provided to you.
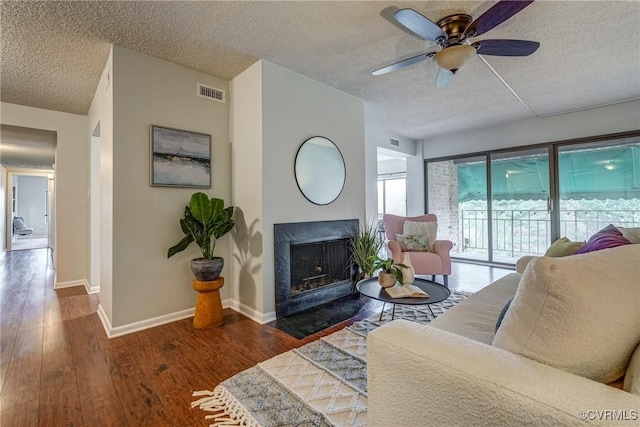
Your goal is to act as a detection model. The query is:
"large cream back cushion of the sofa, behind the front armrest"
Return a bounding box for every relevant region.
[493,245,640,383]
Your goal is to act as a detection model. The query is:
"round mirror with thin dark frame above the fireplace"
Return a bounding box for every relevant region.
[295,136,346,205]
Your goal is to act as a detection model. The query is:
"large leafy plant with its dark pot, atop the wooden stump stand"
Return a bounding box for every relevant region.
[167,192,235,282]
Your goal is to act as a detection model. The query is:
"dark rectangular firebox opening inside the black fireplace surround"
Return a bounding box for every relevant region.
[290,238,351,297]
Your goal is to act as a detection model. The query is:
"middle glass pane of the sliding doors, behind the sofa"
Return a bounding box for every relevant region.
[491,148,551,263]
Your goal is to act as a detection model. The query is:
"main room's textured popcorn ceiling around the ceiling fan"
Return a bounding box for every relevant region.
[0,0,640,139]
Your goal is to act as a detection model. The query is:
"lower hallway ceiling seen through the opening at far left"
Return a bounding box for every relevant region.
[0,125,57,169]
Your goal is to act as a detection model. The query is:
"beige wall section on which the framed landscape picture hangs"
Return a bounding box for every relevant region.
[107,47,231,328]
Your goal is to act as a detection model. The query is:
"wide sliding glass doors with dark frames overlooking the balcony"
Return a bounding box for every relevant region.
[425,132,640,264]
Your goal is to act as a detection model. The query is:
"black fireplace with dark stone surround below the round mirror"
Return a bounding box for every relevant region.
[274,219,358,318]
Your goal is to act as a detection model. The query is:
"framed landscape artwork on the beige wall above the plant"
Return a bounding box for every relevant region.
[151,125,211,188]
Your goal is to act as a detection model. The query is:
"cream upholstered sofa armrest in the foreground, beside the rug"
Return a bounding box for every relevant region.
[367,320,640,426]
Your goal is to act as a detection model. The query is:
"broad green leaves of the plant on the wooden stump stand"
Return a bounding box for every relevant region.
[167,192,235,260]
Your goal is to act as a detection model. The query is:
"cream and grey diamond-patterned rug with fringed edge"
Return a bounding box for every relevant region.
[191,291,468,427]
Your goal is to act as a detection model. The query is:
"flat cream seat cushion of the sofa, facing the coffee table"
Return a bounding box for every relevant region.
[429,273,520,344]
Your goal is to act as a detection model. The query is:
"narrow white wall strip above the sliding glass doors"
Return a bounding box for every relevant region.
[423,100,640,159]
